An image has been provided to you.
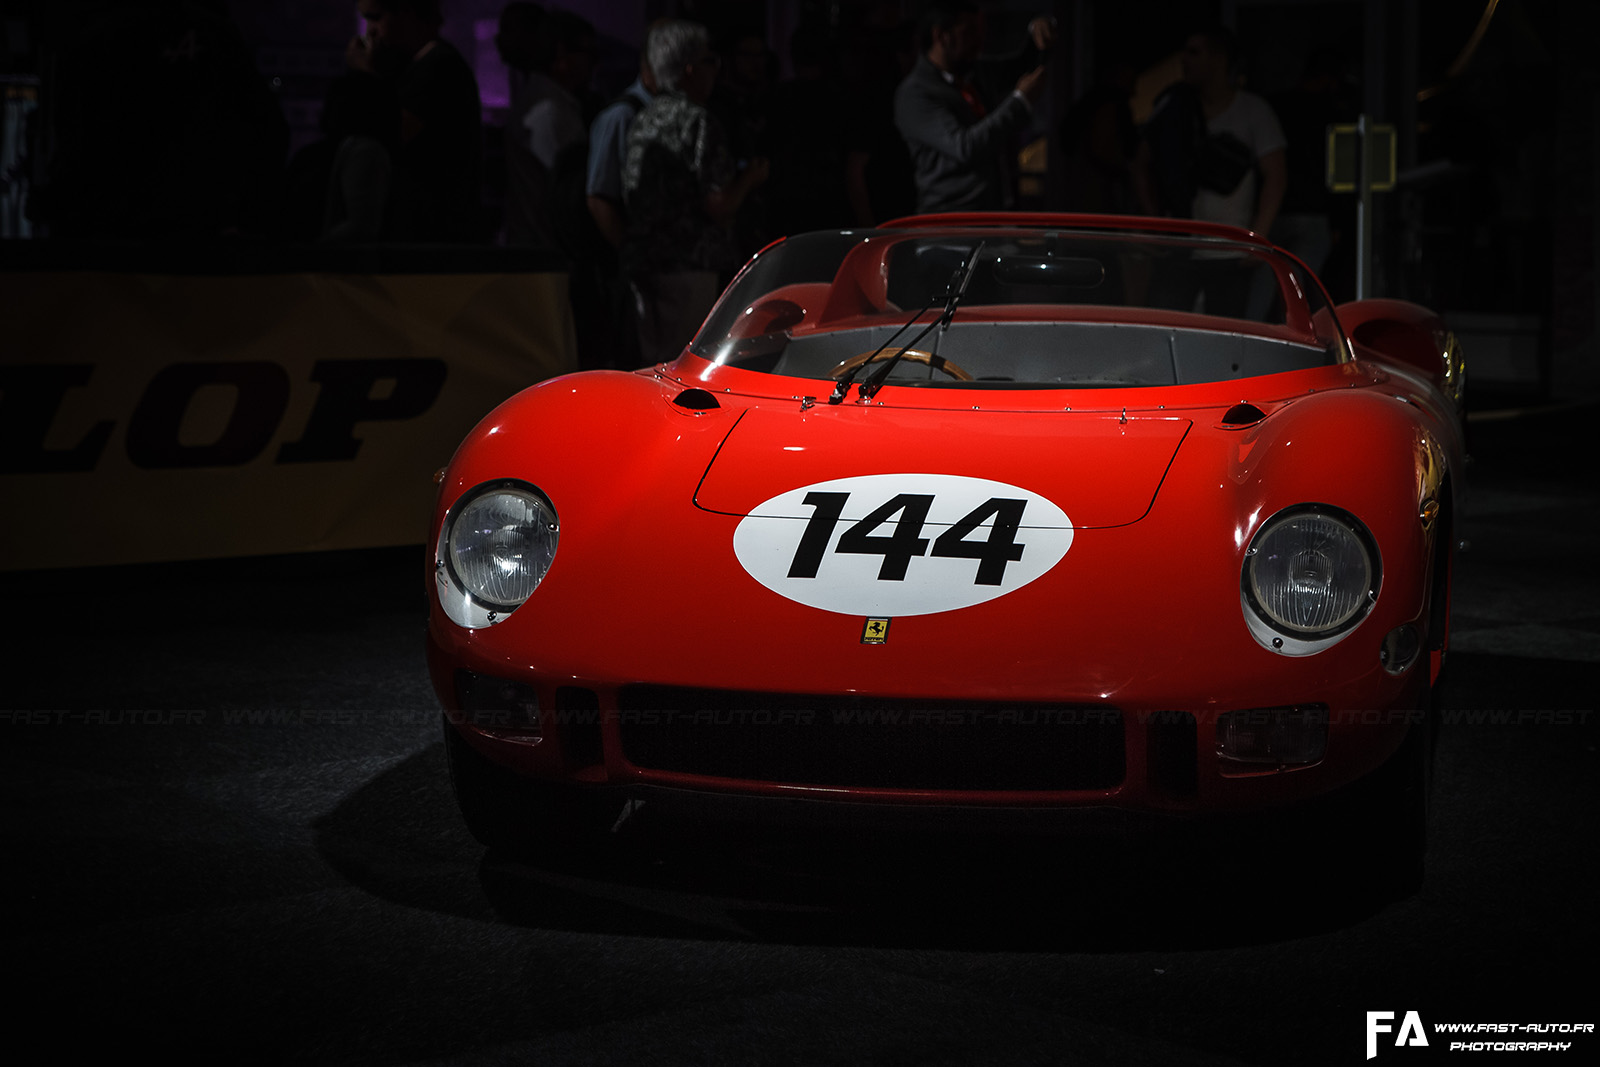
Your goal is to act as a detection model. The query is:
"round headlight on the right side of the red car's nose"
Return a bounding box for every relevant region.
[1240,504,1382,656]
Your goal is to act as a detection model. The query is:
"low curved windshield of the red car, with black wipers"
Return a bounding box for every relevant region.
[691,227,1346,389]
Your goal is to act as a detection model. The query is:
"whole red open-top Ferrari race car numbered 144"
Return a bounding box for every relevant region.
[427,214,1464,873]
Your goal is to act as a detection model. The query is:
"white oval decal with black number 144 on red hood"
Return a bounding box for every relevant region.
[733,474,1072,617]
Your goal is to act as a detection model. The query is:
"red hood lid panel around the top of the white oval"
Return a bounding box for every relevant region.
[694,405,1189,530]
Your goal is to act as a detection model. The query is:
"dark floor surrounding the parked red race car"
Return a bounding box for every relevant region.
[0,398,1600,1065]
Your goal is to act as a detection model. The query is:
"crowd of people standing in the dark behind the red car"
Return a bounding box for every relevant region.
[25,0,1354,366]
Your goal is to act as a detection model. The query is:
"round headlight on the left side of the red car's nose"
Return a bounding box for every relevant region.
[434,480,560,629]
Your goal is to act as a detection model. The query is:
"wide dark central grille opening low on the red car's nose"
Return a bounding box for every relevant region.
[618,685,1126,790]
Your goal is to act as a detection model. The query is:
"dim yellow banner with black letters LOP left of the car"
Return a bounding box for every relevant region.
[0,270,576,569]
